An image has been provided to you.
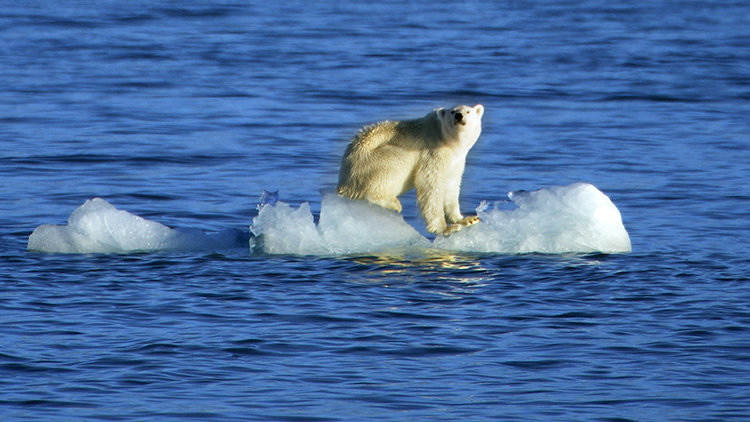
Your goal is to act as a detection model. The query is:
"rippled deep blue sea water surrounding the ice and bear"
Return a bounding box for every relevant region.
[0,0,750,422]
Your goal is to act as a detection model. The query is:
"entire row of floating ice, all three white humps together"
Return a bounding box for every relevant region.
[28,183,631,256]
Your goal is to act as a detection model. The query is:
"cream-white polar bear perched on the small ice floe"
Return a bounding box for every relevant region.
[336,104,484,235]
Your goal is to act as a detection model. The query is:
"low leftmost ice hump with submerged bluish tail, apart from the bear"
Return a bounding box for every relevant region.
[28,198,247,253]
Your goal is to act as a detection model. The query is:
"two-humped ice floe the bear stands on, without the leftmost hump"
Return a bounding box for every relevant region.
[250,183,630,255]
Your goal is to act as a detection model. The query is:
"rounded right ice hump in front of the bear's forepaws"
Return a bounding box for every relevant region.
[433,183,630,254]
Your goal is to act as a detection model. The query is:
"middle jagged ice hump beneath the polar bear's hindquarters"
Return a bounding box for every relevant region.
[250,190,430,255]
